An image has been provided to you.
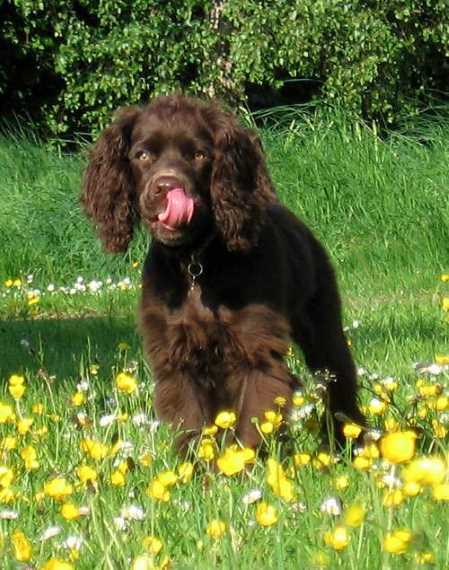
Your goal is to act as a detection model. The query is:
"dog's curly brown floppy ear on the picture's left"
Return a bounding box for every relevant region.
[81,107,141,253]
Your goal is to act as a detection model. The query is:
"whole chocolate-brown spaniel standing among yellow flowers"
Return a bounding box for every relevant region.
[82,95,363,448]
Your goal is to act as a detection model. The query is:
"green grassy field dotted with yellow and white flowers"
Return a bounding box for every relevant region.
[0,111,449,570]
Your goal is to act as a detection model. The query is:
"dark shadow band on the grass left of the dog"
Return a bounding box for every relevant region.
[0,317,141,381]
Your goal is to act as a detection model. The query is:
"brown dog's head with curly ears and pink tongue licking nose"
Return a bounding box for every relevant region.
[82,96,276,252]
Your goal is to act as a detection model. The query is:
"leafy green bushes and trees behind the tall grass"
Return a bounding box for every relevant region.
[0,0,449,134]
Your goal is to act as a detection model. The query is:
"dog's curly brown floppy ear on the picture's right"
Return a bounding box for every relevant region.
[211,113,277,251]
